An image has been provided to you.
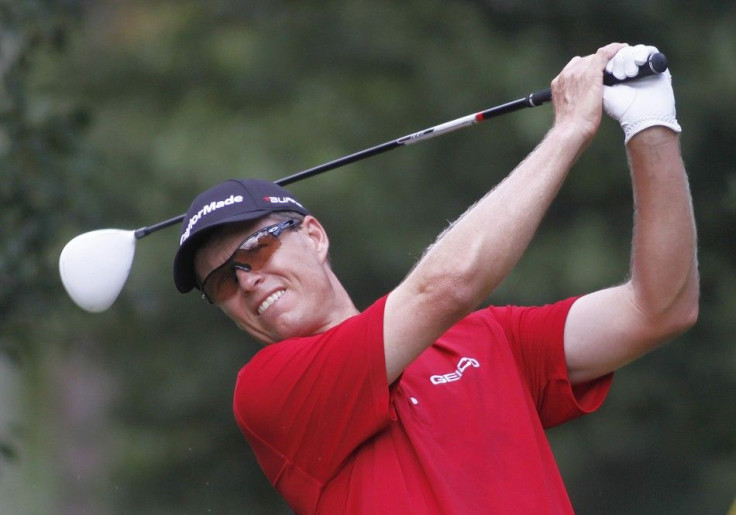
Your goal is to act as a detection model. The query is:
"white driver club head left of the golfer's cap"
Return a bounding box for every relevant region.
[59,229,136,313]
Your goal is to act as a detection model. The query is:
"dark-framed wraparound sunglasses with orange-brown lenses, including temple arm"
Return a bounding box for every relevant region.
[200,218,302,304]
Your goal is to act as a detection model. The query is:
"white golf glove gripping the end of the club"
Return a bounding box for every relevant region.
[603,45,682,143]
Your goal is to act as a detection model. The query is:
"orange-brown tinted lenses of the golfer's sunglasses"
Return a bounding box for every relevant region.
[203,233,281,304]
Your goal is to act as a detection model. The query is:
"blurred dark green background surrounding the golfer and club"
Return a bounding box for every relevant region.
[0,0,736,514]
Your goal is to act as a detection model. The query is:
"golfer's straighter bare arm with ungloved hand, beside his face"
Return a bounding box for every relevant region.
[384,44,623,383]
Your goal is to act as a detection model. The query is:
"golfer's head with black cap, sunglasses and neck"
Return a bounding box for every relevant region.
[174,179,355,343]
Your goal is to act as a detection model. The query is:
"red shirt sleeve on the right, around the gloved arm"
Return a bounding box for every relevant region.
[489,298,613,428]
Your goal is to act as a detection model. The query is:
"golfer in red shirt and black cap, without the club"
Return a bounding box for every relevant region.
[174,43,698,514]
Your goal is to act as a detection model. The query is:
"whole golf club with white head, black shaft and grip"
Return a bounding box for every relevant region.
[59,53,667,313]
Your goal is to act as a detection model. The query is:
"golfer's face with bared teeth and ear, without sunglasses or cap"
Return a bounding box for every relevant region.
[194,216,331,344]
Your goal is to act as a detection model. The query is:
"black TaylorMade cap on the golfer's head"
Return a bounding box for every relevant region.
[174,179,309,293]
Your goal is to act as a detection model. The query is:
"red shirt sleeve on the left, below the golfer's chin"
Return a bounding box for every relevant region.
[233,297,390,484]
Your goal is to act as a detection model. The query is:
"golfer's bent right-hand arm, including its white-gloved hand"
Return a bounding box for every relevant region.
[565,46,699,383]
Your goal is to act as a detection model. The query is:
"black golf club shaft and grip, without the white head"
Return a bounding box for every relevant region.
[135,53,667,239]
